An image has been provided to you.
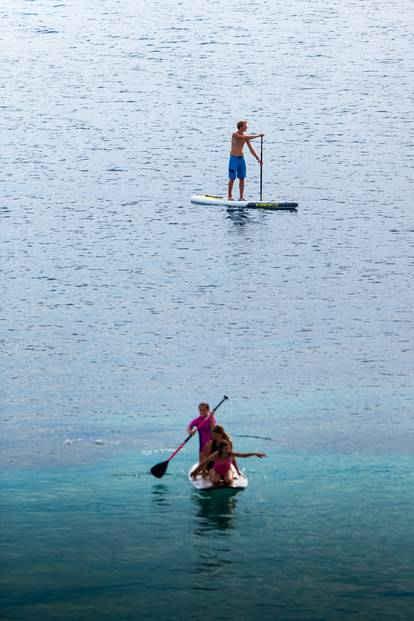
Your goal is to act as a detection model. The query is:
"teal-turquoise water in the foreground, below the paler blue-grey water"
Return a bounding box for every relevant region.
[1,448,414,621]
